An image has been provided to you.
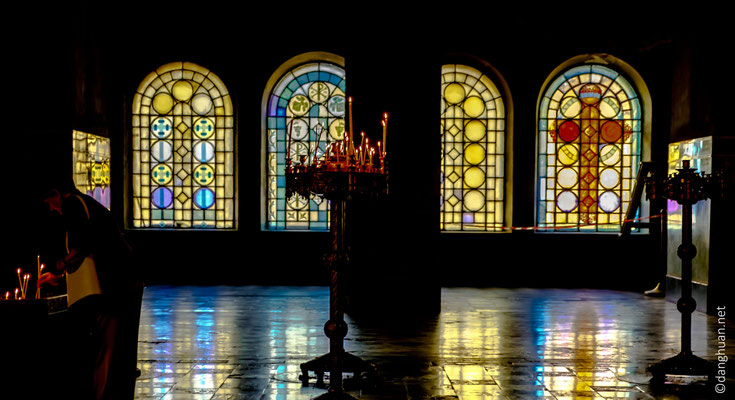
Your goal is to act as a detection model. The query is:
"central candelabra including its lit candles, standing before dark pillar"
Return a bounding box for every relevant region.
[285,105,388,399]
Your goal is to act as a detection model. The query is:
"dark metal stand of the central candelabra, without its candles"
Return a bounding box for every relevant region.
[286,160,388,399]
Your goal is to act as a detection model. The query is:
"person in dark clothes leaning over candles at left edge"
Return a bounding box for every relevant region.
[38,177,143,399]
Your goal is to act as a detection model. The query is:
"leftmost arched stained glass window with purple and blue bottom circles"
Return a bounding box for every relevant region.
[132,62,235,229]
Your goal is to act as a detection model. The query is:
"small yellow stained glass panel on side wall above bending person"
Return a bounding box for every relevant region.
[72,131,110,209]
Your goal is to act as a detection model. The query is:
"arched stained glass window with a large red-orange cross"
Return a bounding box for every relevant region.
[537,64,642,232]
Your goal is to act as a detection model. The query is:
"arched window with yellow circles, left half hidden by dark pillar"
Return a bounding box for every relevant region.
[440,64,505,232]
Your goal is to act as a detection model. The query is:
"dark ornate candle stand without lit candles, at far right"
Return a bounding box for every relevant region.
[646,160,725,385]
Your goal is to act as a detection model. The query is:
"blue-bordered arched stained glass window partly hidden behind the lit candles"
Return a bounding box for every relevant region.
[265,61,347,230]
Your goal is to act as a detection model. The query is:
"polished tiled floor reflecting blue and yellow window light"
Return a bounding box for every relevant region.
[136,286,735,400]
